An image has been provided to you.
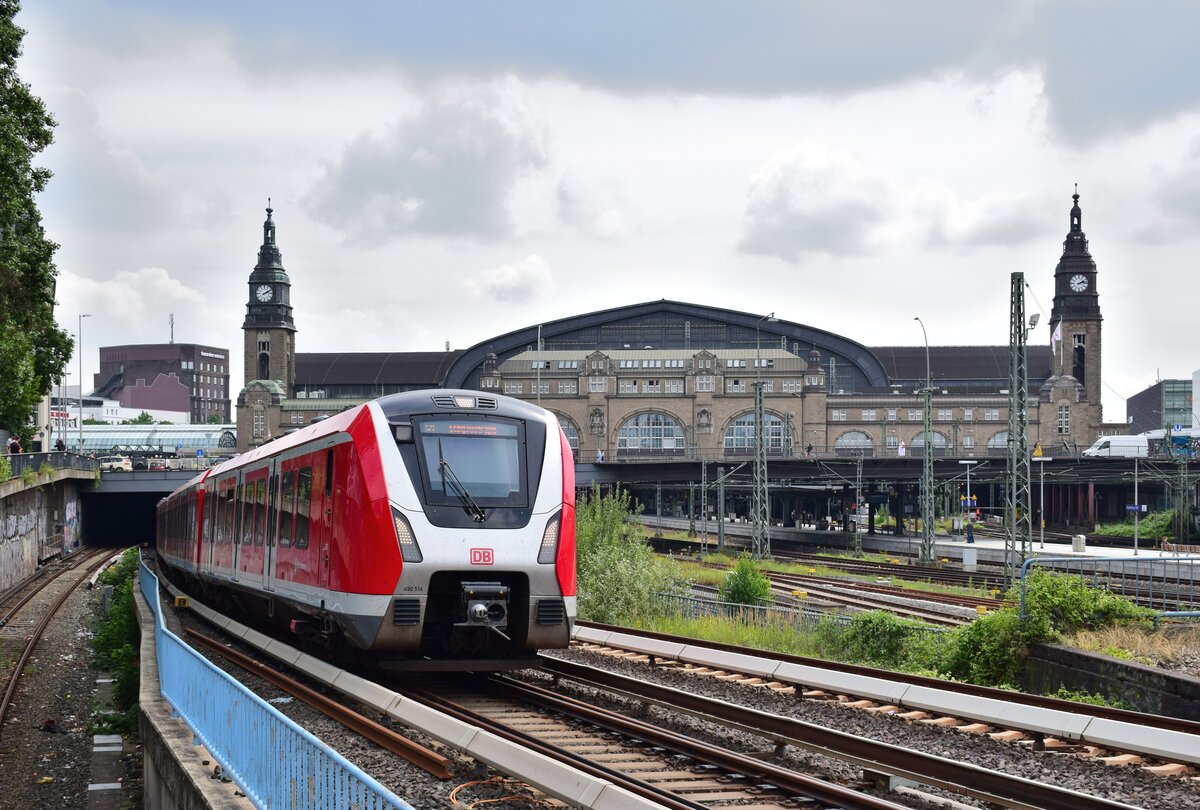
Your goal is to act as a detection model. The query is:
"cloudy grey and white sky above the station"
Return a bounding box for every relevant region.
[18,0,1200,420]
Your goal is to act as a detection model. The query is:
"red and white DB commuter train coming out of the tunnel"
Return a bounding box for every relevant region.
[157,389,576,668]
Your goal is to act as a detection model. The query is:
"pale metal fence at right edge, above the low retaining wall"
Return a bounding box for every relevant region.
[1021,556,1200,618]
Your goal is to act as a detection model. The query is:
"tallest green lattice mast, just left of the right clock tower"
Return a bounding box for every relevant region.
[1004,272,1033,586]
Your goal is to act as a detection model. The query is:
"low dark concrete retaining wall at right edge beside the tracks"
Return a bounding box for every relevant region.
[1022,644,1200,720]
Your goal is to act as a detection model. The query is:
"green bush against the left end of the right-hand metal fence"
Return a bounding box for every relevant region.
[1008,569,1153,632]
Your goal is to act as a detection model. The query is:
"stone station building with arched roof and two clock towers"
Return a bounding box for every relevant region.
[238,193,1128,461]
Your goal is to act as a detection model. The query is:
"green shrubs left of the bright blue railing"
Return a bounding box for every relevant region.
[91,550,142,731]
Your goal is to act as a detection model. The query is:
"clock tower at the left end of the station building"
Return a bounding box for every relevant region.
[241,202,296,396]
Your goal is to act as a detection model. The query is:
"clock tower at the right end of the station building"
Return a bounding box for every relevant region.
[1050,186,1104,409]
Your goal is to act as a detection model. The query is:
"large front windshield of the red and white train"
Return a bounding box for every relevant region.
[413,416,528,506]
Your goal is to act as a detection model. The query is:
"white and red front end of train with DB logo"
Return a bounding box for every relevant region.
[372,390,576,668]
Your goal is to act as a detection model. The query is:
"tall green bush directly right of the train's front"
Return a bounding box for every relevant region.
[575,487,680,624]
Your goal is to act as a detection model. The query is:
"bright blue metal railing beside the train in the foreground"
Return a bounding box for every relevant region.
[140,563,414,810]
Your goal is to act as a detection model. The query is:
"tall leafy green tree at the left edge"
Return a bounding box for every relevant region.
[0,0,72,432]
